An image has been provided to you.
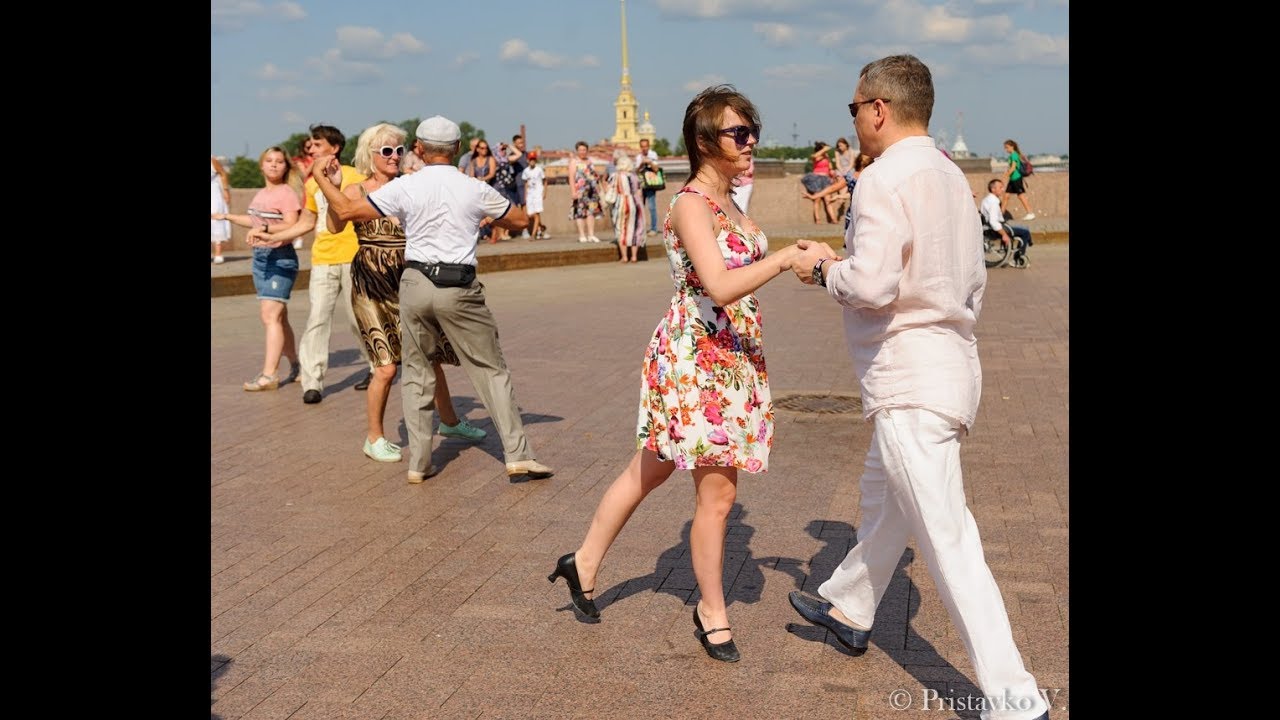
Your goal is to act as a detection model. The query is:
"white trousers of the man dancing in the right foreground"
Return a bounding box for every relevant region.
[818,409,1048,720]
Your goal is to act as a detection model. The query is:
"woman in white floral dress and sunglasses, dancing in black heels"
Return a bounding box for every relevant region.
[550,86,799,662]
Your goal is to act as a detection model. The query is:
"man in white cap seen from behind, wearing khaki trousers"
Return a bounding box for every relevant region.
[312,115,553,483]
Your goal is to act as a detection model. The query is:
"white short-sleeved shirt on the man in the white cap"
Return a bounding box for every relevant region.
[369,165,511,265]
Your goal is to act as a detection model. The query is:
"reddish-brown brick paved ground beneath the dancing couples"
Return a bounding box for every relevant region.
[210,245,1070,720]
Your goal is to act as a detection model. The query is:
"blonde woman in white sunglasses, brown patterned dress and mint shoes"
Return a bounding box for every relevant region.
[328,123,488,462]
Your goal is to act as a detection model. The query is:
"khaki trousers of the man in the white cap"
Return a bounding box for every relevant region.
[399,268,534,473]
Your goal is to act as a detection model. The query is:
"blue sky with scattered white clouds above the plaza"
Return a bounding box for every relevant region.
[210,0,1070,156]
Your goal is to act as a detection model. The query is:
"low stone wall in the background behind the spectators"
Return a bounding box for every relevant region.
[228,172,1071,250]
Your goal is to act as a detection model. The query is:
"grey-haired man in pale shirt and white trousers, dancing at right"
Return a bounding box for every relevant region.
[790,55,1048,720]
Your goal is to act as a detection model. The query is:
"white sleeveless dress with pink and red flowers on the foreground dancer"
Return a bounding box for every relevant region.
[636,187,773,473]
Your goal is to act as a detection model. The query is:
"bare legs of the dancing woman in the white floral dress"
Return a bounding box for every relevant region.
[573,450,737,643]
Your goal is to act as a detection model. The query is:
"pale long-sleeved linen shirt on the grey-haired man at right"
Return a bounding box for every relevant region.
[827,136,987,428]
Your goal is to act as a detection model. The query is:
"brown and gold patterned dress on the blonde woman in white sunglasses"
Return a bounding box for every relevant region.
[351,186,460,365]
